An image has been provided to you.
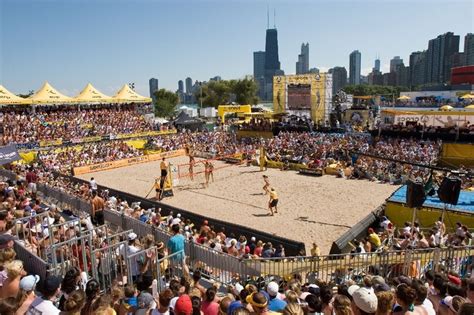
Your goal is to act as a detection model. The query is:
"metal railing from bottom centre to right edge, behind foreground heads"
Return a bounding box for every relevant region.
[242,247,474,284]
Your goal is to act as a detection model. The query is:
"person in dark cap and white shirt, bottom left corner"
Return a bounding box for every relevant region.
[26,276,61,315]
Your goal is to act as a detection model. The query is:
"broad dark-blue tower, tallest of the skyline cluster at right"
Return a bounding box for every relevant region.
[426,32,460,83]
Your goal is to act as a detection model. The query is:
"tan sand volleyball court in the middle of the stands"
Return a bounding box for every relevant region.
[78,157,398,254]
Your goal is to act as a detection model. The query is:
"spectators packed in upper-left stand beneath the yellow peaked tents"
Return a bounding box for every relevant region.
[0,105,153,145]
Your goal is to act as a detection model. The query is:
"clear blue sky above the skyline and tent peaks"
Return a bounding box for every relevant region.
[0,0,474,95]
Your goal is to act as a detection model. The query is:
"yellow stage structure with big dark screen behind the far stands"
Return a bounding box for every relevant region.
[273,73,332,124]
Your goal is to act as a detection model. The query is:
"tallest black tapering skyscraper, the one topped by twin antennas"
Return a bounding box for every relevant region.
[264,28,281,100]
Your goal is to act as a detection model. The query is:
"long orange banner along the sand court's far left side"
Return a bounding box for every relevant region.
[73,149,185,175]
